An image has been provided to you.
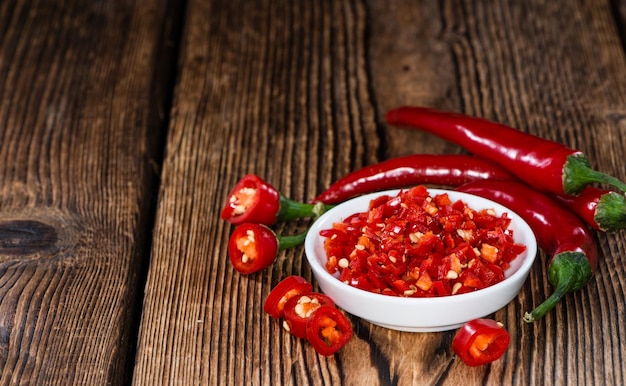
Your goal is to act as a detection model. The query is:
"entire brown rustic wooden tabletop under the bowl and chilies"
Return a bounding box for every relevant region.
[0,0,626,385]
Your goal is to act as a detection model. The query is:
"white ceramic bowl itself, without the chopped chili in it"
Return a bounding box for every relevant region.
[304,189,537,332]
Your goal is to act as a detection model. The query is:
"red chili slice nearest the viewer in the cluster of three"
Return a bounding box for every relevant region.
[306,306,352,356]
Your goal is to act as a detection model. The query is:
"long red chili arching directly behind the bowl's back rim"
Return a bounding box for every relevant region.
[313,154,514,204]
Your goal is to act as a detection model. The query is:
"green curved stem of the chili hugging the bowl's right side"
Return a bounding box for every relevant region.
[524,252,592,323]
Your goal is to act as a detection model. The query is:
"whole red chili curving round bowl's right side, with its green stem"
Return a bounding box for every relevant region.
[458,180,598,322]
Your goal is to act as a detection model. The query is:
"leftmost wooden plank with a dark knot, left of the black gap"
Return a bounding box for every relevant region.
[0,0,174,385]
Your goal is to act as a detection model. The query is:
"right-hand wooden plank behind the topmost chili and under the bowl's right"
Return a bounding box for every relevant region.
[368,1,626,384]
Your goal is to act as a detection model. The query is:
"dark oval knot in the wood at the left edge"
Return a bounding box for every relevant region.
[0,220,58,255]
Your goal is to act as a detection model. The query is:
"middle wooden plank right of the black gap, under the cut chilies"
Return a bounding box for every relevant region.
[134,1,380,385]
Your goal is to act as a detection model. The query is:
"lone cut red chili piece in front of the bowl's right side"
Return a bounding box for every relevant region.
[452,319,511,366]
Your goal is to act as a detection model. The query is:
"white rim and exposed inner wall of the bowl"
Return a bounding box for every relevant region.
[304,187,537,306]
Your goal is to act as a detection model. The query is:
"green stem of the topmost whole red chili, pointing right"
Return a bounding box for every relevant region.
[563,154,626,195]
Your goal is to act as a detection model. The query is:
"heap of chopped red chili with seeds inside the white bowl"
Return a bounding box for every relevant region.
[320,185,526,297]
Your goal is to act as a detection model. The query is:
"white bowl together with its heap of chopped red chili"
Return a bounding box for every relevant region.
[305,186,537,332]
